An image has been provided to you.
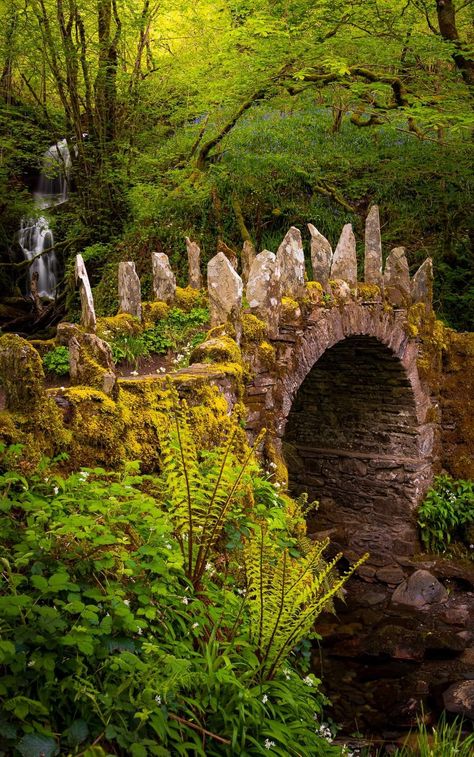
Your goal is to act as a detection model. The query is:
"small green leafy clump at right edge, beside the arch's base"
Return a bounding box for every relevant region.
[418,475,474,553]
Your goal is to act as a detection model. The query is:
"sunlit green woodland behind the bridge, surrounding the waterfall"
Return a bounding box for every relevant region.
[0,0,474,328]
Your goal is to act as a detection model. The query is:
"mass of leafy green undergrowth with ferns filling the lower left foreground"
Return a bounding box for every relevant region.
[0,398,366,757]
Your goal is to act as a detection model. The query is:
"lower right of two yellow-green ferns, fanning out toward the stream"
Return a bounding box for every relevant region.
[245,528,367,680]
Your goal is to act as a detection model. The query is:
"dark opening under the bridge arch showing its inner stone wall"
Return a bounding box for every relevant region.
[283,335,431,565]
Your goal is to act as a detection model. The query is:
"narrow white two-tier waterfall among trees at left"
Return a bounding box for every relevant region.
[18,139,71,299]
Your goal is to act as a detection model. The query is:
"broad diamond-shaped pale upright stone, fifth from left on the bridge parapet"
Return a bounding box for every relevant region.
[207,252,243,340]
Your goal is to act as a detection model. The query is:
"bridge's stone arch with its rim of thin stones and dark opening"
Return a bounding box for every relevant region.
[274,303,436,565]
